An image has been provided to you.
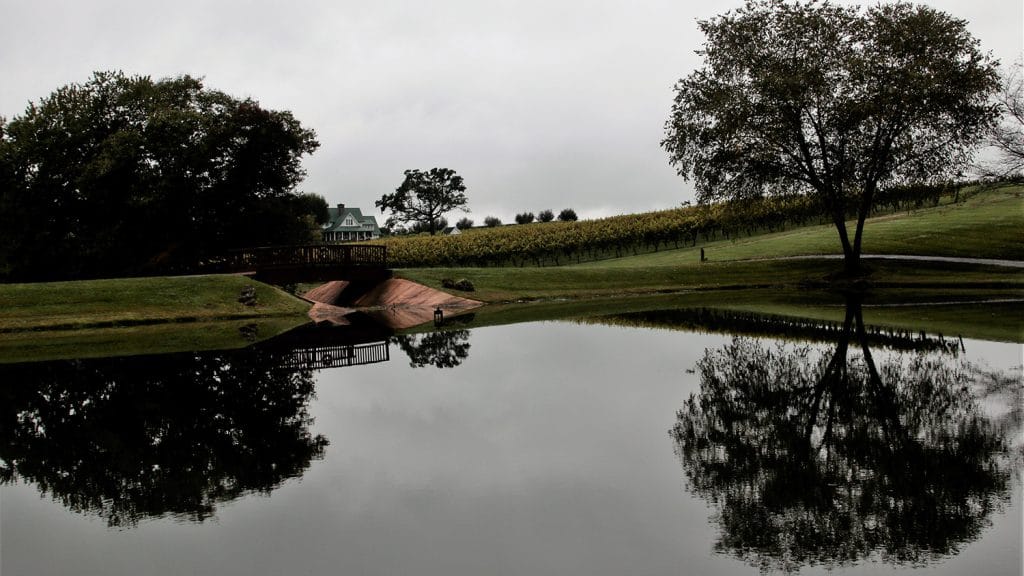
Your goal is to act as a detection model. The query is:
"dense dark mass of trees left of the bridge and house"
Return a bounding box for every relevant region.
[0,72,318,280]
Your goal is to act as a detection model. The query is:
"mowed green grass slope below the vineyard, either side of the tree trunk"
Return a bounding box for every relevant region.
[399,187,1024,302]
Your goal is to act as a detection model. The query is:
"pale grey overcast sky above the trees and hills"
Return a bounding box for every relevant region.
[0,0,1024,223]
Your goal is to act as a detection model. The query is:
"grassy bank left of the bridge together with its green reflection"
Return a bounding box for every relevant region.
[0,275,309,363]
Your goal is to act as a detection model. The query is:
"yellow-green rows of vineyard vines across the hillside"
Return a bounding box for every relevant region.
[378,178,995,268]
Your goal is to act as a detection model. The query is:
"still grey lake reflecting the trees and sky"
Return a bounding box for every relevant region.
[0,297,1024,576]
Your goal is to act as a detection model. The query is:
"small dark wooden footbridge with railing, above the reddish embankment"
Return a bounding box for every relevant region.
[213,244,391,284]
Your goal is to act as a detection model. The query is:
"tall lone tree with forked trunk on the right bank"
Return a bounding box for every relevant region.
[662,0,998,274]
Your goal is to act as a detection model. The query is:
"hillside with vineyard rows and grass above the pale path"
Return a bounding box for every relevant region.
[378,186,1024,268]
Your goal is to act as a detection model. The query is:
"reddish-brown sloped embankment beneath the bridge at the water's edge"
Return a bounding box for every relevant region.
[303,279,482,330]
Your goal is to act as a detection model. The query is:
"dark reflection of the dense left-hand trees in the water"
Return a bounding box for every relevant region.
[0,349,328,527]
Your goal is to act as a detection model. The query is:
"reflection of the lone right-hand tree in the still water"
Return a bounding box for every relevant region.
[670,293,1021,571]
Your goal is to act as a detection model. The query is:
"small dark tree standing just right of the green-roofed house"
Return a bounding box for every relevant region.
[375,168,467,236]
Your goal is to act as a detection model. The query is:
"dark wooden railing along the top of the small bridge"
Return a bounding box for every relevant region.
[221,244,387,272]
